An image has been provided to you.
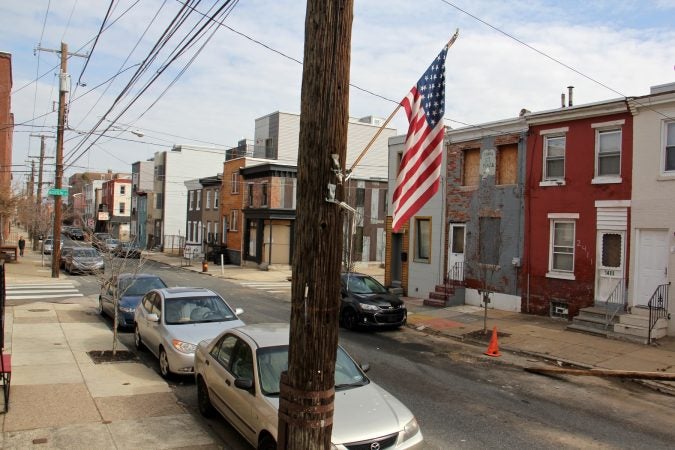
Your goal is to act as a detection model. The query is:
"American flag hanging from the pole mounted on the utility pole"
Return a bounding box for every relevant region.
[392,46,448,232]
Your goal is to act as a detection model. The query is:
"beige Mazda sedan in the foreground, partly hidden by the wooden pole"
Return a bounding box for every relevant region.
[195,324,423,450]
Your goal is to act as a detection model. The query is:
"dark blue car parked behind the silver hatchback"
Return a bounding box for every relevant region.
[98,273,167,328]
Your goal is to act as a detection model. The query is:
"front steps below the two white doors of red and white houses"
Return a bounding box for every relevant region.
[567,306,668,344]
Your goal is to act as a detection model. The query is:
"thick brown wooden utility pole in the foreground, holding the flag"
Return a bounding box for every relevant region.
[277,0,353,449]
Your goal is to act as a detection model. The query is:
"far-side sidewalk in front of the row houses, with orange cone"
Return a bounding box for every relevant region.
[148,253,675,395]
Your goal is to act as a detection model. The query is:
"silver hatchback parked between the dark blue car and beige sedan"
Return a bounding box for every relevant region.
[134,288,244,378]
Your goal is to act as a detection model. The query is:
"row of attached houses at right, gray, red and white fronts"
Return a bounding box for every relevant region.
[385,84,675,340]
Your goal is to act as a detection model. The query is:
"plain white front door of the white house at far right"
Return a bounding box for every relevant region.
[633,230,668,306]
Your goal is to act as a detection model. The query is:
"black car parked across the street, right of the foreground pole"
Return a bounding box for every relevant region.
[340,272,408,329]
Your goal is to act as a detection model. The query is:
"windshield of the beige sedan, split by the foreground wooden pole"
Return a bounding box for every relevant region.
[256,345,370,397]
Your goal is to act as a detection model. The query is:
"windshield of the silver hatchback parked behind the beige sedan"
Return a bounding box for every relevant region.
[164,296,237,325]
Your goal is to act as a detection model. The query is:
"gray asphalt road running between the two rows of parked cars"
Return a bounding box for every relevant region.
[72,256,675,449]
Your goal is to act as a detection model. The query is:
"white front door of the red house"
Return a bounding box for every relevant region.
[595,231,625,304]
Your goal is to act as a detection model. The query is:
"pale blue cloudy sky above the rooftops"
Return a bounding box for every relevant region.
[0,0,675,190]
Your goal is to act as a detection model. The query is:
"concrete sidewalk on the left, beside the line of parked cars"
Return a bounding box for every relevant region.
[0,250,221,449]
